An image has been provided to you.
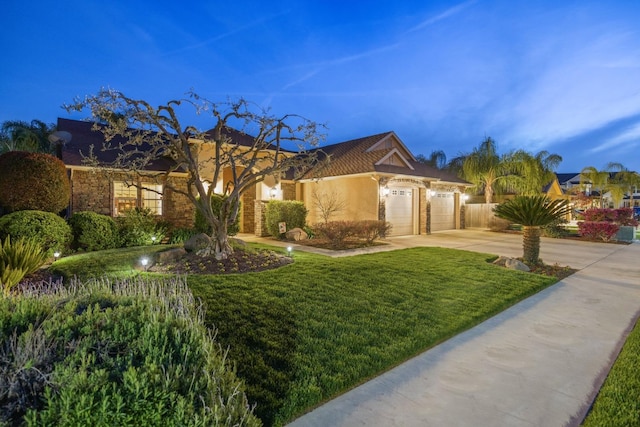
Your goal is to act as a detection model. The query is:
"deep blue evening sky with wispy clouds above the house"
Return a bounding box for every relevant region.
[0,0,640,172]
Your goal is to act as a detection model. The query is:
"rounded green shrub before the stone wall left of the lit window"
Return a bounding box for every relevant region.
[69,211,119,251]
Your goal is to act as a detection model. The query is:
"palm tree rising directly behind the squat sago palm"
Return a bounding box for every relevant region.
[509,150,562,196]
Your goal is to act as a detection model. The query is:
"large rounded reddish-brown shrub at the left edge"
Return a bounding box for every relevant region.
[0,151,71,213]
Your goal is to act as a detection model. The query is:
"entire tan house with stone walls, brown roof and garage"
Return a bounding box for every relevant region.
[58,119,469,235]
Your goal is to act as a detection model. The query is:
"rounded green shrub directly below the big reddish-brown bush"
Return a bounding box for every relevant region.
[0,211,73,256]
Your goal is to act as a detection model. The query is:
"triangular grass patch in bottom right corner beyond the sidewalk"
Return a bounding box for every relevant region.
[583,316,640,427]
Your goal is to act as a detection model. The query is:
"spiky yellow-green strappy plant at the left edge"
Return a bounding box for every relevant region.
[0,236,47,296]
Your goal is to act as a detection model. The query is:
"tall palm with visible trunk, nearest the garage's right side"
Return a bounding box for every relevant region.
[462,137,513,203]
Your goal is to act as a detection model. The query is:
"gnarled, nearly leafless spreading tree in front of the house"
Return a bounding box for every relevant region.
[65,89,324,259]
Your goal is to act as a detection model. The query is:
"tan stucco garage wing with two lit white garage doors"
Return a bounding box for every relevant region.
[297,132,470,235]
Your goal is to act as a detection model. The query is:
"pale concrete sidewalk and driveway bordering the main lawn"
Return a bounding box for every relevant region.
[282,234,640,427]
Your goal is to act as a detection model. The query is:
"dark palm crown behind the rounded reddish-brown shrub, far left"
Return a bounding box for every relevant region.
[0,120,55,153]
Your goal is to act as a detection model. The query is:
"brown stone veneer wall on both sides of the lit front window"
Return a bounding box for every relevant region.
[70,170,195,228]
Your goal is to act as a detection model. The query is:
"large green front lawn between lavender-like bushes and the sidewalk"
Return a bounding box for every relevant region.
[55,248,555,425]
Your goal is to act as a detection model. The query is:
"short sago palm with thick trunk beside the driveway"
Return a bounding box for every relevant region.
[493,195,571,265]
